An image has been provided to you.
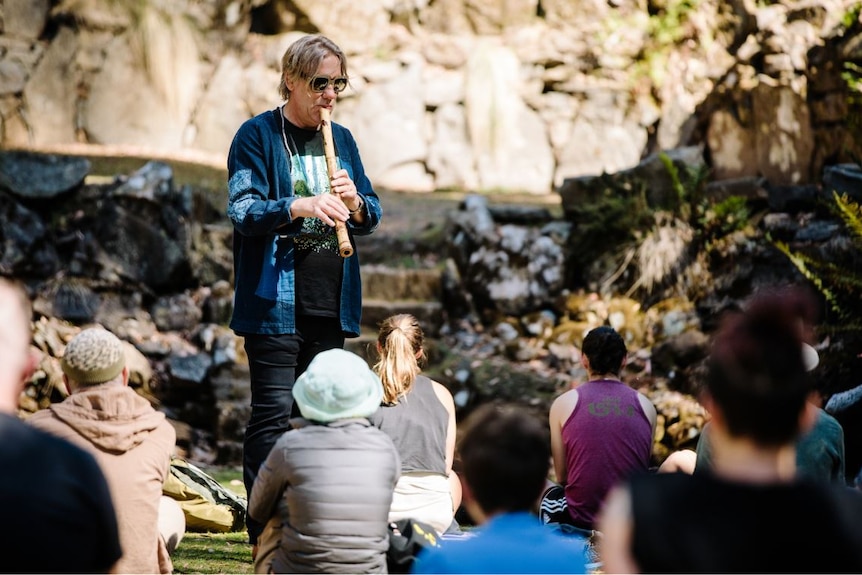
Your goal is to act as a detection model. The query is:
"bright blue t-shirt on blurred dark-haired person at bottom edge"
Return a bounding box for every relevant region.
[411,511,586,573]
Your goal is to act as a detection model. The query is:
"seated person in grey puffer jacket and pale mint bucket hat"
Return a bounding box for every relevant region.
[248,349,401,573]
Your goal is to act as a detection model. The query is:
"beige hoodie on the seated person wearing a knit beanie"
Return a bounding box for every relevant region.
[27,385,176,573]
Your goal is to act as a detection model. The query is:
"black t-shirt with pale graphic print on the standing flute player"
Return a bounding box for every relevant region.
[284,121,344,317]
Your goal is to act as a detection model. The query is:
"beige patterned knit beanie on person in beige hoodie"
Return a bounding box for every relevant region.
[60,328,126,385]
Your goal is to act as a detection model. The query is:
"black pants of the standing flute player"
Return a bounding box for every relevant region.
[243,316,344,544]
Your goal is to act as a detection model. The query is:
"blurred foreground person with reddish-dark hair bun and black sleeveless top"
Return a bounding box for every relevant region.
[599,292,862,573]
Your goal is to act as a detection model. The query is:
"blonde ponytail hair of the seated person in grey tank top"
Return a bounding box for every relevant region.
[374,313,425,403]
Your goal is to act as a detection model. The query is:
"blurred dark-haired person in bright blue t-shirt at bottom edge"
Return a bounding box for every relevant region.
[411,405,585,573]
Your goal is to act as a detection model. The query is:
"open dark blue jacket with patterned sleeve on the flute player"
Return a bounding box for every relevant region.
[227,108,383,337]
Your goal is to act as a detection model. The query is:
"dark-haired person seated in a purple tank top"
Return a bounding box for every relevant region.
[540,326,656,532]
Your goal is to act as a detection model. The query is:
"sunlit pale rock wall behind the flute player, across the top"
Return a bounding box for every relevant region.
[0,0,862,194]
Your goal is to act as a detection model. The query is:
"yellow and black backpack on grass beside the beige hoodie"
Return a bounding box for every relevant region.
[162,458,248,533]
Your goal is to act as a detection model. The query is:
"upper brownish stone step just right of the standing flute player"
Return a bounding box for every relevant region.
[362,264,442,302]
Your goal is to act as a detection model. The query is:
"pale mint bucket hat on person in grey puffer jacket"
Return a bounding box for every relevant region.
[293,349,383,423]
